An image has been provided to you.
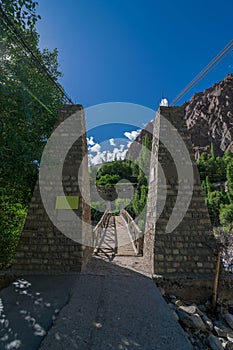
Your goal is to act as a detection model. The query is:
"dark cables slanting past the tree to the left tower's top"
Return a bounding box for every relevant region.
[0,5,73,104]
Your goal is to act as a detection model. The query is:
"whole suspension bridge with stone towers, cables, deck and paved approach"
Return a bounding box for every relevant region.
[0,6,233,350]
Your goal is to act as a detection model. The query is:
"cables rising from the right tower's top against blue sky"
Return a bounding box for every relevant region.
[171,40,233,106]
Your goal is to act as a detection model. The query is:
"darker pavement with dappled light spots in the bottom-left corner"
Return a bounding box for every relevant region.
[0,275,77,350]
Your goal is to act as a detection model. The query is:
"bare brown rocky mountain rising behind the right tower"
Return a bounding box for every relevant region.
[127,74,233,160]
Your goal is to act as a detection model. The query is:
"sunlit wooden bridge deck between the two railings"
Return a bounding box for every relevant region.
[94,216,136,257]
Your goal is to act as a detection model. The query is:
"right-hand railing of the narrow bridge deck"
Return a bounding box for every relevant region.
[120,209,143,255]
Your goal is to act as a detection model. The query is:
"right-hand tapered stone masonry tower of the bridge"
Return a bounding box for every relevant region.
[144,107,216,276]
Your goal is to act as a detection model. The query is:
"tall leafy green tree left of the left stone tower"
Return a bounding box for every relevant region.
[0,0,62,265]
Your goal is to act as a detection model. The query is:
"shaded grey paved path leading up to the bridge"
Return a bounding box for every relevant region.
[0,257,192,350]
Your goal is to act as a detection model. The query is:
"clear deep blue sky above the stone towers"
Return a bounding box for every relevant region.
[37,0,233,164]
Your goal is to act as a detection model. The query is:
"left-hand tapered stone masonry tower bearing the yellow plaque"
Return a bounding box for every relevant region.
[13,105,92,272]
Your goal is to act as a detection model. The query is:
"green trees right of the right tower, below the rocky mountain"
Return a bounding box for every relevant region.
[198,148,233,229]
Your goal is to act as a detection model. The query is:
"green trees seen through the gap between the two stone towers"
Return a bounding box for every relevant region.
[90,135,152,229]
